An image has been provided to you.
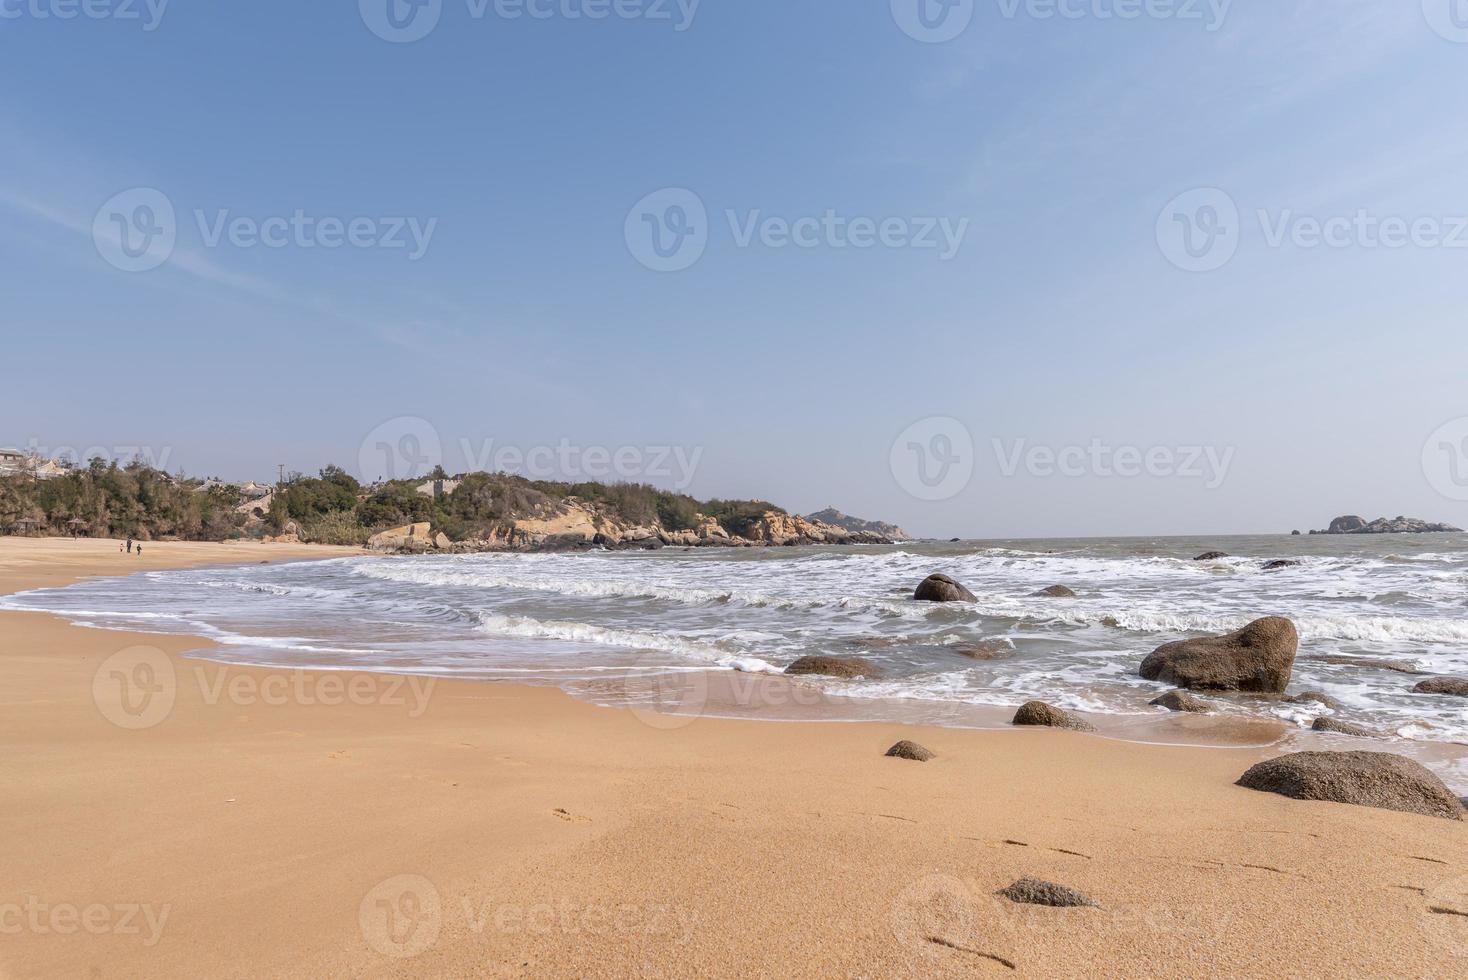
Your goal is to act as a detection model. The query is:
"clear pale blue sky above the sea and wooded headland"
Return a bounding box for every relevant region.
[0,0,1468,535]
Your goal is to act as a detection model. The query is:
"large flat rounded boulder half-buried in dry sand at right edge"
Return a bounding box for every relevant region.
[1239,753,1464,820]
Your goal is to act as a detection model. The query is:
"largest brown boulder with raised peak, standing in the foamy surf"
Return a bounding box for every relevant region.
[1139,616,1299,694]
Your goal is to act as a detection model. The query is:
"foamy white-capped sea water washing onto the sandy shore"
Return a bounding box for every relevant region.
[11,534,1468,785]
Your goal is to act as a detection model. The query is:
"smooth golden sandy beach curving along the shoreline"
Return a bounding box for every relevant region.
[0,538,1468,979]
